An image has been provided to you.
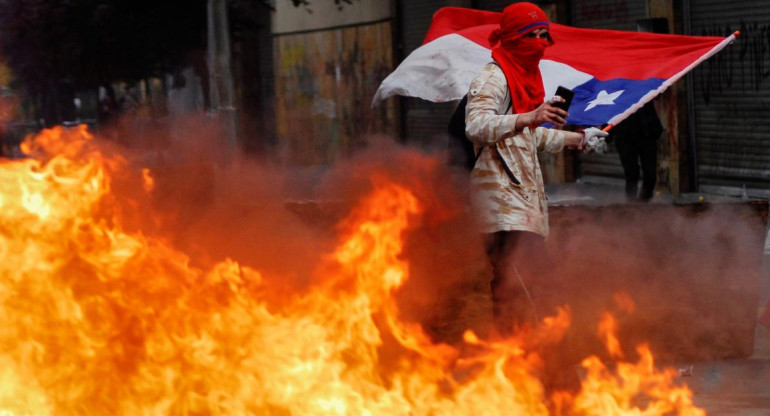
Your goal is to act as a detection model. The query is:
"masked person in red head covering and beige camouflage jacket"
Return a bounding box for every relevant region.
[465,2,607,335]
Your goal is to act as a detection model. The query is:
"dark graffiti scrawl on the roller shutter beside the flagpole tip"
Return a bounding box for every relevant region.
[696,22,770,105]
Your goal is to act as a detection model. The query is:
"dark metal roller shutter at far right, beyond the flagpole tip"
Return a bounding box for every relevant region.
[690,0,770,189]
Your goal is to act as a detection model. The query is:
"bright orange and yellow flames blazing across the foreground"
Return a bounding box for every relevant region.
[0,127,703,416]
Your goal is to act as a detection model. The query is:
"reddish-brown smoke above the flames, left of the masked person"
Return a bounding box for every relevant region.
[102,117,488,328]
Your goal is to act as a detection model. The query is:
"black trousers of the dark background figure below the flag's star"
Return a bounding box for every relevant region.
[615,136,658,201]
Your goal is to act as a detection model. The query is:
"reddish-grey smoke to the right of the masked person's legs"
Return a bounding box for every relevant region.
[549,198,766,364]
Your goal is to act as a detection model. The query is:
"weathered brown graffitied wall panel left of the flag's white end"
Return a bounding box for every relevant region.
[274,22,397,165]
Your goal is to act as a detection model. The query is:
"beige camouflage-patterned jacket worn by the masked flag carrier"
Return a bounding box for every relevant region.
[465,63,564,236]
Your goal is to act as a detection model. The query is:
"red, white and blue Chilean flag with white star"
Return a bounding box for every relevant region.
[372,7,737,126]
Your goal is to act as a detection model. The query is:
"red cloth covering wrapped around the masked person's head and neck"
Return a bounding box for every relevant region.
[489,2,553,114]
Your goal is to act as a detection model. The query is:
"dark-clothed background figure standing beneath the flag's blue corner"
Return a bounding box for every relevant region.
[610,102,663,202]
